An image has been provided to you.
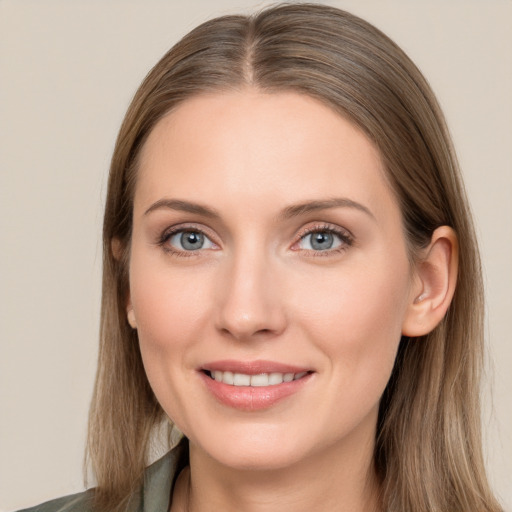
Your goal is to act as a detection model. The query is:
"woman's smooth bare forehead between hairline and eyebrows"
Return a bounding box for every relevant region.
[135,89,396,224]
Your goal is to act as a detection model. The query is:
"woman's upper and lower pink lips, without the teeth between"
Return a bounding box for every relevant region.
[198,361,312,411]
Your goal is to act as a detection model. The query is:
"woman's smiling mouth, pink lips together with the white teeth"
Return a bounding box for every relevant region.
[199,361,314,411]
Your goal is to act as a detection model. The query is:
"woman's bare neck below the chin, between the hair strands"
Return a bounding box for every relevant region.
[171,424,380,512]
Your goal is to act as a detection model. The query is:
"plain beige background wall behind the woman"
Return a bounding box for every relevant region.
[0,0,512,511]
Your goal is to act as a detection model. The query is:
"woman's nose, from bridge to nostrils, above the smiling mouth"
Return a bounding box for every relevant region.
[216,247,287,341]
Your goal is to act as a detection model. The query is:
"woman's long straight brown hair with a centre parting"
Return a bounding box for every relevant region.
[88,4,501,512]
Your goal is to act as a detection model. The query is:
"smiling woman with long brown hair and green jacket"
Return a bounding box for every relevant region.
[19,5,501,512]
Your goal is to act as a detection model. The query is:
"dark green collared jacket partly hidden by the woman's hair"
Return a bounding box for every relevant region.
[18,442,188,512]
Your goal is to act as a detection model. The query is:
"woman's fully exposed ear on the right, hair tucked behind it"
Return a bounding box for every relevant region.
[402,226,459,337]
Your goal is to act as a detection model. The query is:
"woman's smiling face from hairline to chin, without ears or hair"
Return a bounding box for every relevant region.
[129,89,414,468]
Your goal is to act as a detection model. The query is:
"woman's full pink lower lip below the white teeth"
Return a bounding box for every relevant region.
[199,372,312,411]
